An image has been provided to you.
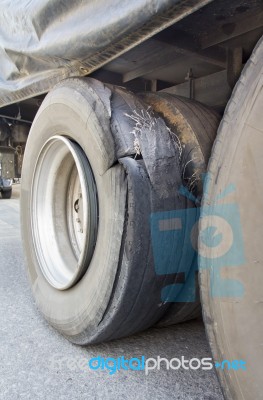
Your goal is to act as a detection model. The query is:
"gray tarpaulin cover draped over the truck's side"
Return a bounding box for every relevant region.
[0,0,208,106]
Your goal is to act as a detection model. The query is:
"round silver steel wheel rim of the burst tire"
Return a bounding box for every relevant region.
[30,135,98,290]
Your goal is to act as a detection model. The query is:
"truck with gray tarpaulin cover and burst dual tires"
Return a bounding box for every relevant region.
[0,0,263,400]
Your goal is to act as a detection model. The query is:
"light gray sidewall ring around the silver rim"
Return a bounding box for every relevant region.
[21,79,127,335]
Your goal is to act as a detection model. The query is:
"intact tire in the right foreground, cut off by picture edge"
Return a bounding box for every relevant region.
[199,38,263,400]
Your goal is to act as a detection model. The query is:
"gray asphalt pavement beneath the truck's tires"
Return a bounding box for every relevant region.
[0,186,223,400]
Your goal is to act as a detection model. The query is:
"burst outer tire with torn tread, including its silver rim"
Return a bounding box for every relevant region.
[21,78,187,344]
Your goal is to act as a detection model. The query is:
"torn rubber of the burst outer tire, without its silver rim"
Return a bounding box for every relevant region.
[21,78,187,344]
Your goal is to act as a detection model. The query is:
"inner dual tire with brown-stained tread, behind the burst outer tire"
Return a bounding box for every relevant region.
[140,92,220,326]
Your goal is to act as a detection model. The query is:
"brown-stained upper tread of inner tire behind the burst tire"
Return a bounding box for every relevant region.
[140,92,221,203]
